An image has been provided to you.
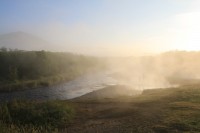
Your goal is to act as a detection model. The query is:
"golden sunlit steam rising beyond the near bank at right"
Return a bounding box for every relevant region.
[108,51,200,90]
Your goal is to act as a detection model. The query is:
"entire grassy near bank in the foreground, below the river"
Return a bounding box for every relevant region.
[0,85,200,133]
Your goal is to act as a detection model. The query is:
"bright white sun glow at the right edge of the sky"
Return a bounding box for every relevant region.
[172,12,200,50]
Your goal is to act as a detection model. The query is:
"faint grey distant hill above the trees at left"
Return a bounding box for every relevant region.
[0,31,52,50]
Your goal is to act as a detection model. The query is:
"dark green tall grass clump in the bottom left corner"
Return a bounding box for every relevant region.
[0,100,74,133]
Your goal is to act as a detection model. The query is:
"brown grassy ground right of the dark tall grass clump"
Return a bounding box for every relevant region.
[67,85,200,133]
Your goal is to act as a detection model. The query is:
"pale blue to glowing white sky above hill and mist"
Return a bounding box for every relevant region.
[0,0,200,56]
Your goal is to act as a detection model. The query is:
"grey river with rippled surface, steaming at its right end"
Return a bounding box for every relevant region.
[0,72,172,101]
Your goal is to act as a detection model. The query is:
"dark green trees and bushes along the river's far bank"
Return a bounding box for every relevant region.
[0,48,103,91]
